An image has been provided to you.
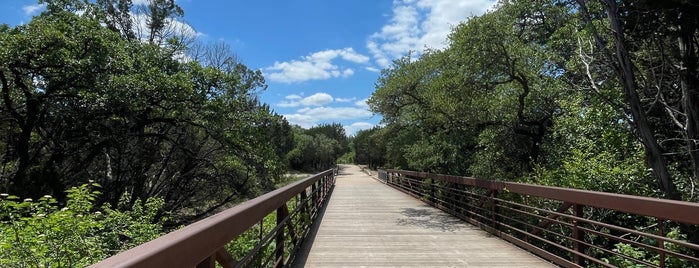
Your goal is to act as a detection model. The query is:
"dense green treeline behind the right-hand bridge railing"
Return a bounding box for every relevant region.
[354,0,699,201]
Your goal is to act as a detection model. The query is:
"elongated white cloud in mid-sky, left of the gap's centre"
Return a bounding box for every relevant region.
[265,48,369,83]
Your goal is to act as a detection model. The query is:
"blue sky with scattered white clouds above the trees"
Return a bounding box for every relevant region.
[0,0,495,135]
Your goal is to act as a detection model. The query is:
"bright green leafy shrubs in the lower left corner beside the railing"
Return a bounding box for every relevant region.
[0,183,164,267]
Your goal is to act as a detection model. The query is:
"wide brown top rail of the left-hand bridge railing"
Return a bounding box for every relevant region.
[91,169,334,267]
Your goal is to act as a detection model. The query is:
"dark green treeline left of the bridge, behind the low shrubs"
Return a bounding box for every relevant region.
[0,0,347,226]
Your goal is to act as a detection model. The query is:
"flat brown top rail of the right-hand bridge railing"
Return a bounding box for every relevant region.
[386,169,699,225]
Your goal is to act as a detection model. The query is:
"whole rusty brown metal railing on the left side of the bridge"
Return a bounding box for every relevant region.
[91,169,336,267]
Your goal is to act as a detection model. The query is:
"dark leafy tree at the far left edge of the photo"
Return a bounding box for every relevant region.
[0,12,127,199]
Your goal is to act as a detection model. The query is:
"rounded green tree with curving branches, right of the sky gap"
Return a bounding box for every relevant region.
[369,1,567,178]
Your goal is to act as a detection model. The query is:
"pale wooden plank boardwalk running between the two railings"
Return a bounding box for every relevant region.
[296,166,552,267]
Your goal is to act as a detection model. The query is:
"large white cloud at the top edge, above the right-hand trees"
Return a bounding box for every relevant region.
[367,0,495,68]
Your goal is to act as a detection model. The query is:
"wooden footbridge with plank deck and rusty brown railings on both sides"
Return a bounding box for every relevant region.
[92,165,699,267]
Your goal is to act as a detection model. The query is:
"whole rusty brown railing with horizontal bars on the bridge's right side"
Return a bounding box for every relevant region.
[385,169,699,267]
